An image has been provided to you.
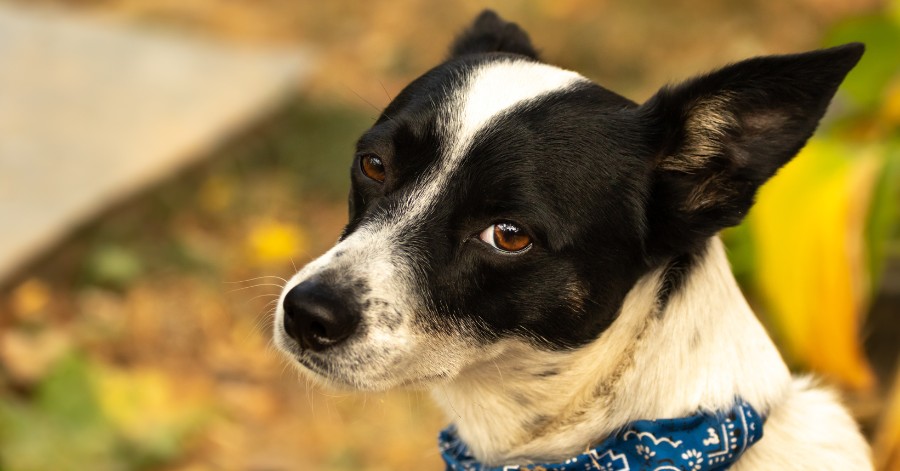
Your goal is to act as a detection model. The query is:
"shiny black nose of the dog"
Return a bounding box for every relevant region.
[282,280,359,352]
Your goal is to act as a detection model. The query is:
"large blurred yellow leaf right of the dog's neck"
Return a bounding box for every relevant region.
[750,140,882,389]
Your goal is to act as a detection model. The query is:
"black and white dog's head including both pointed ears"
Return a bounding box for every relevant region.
[274,12,863,390]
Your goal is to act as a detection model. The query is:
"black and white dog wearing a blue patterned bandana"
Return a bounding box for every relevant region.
[274,11,872,470]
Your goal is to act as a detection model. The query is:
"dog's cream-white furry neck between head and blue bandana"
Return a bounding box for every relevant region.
[432,238,790,465]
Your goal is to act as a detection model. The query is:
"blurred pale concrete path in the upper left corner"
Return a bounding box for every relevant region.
[0,5,310,283]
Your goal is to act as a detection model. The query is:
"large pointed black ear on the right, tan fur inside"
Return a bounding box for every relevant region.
[638,43,864,255]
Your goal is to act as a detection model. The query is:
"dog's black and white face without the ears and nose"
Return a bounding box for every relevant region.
[274,54,648,387]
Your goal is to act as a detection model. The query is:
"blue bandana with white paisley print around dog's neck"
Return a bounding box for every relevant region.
[440,401,763,471]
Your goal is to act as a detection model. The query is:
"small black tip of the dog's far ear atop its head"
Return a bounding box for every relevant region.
[450,10,538,59]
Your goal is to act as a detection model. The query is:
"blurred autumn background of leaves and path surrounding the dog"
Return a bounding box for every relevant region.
[0,0,900,471]
